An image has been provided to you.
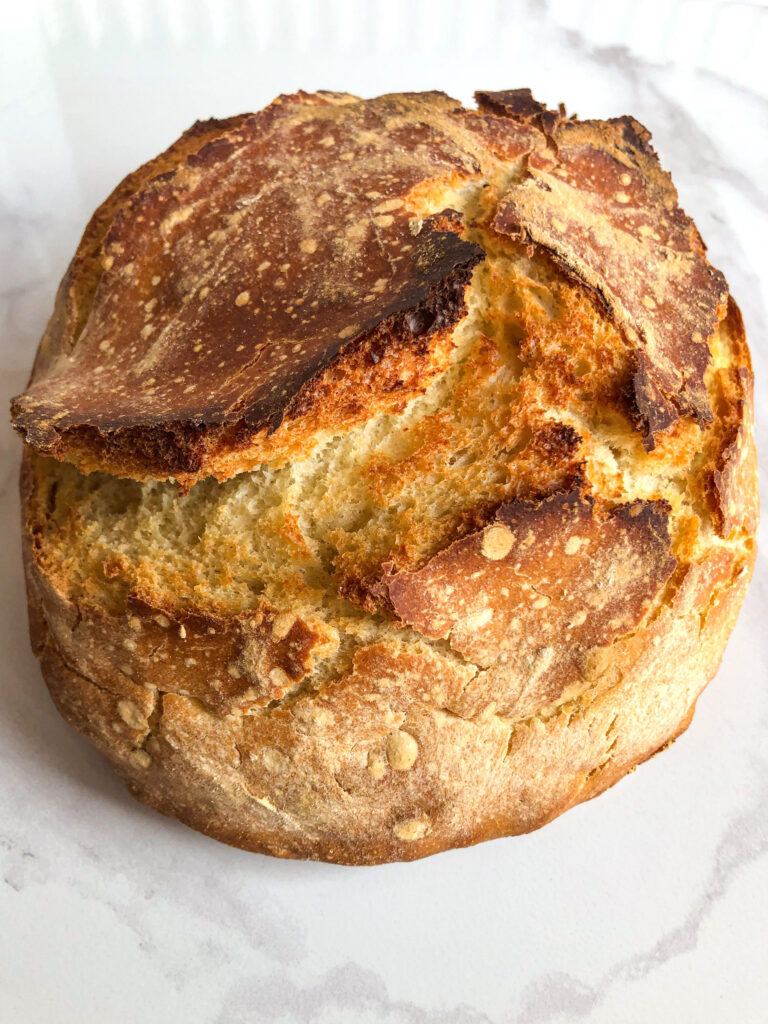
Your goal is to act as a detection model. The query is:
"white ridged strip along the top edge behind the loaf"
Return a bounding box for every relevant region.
[28,0,768,89]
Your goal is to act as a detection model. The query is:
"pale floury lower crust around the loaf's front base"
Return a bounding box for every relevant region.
[33,528,753,864]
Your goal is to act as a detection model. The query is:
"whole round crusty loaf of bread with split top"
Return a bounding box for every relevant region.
[12,90,757,864]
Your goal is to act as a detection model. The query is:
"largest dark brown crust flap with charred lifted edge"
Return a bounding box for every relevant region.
[12,95,482,476]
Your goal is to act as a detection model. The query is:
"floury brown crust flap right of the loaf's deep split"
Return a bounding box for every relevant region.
[477,90,728,451]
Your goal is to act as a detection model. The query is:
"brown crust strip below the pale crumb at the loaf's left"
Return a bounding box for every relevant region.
[22,455,338,715]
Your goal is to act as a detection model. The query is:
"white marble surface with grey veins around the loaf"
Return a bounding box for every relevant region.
[0,0,768,1024]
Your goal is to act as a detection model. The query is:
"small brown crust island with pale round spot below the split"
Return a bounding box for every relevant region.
[388,489,676,713]
